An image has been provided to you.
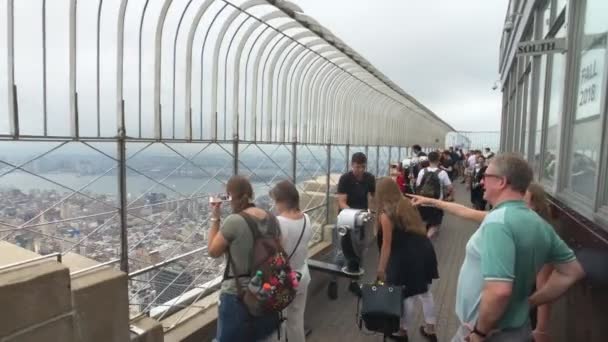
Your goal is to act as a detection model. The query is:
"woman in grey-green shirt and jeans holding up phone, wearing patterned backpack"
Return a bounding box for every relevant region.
[208,176,281,342]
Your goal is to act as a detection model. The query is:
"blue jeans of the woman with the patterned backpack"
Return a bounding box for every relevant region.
[216,293,279,342]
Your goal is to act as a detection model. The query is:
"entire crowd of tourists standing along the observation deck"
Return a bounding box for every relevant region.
[208,145,584,342]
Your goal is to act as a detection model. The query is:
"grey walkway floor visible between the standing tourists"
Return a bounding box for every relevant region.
[306,184,477,342]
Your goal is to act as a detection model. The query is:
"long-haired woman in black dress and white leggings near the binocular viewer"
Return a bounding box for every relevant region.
[374,178,439,341]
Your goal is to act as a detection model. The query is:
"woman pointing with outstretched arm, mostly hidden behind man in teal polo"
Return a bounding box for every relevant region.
[408,183,553,342]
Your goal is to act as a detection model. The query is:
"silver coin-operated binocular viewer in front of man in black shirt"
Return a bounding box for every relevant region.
[336,209,374,276]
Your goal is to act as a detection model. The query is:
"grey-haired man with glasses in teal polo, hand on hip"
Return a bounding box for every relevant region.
[452,154,584,342]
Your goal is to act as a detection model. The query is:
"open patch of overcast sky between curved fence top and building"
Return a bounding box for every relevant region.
[294,0,508,131]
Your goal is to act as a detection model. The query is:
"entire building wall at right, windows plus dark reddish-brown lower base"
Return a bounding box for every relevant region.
[500,0,608,341]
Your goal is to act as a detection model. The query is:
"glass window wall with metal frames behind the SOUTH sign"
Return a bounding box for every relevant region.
[500,0,608,230]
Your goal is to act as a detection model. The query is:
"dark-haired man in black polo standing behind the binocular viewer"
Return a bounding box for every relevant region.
[337,152,376,293]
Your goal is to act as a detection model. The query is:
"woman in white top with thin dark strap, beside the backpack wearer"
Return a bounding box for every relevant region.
[270,181,312,342]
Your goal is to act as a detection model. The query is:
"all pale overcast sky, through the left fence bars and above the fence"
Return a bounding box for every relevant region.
[0,0,508,138]
